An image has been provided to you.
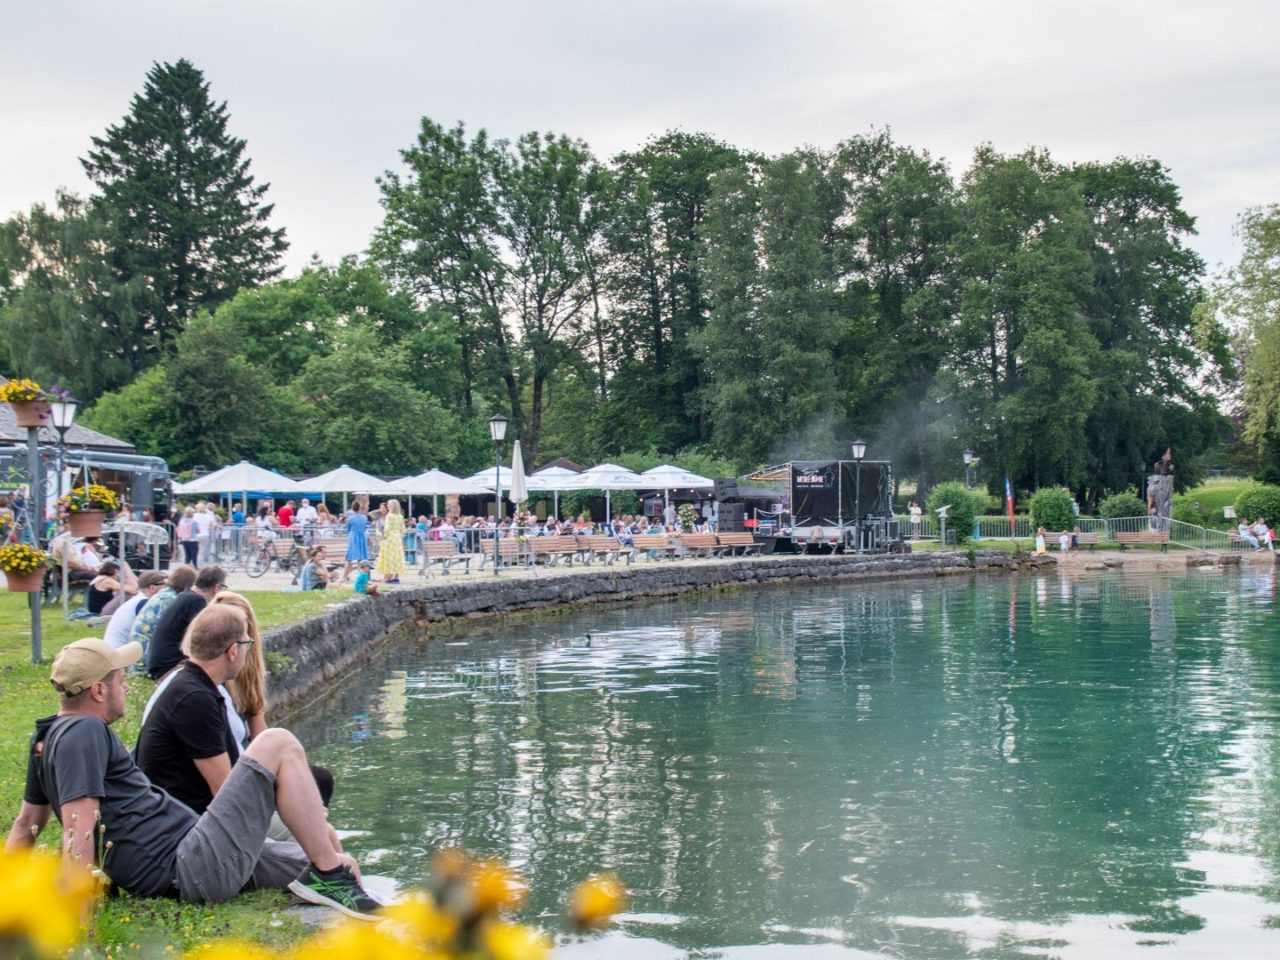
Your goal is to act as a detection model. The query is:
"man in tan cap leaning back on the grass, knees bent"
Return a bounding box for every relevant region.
[5,640,379,920]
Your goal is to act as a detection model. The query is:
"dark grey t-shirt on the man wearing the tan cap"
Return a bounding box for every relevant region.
[23,716,196,897]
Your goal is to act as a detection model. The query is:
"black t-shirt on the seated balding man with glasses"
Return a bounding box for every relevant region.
[137,663,239,813]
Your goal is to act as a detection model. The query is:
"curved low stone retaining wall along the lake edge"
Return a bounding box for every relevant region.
[266,553,1018,710]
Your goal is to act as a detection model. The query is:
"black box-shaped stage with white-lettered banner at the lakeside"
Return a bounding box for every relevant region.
[748,460,902,553]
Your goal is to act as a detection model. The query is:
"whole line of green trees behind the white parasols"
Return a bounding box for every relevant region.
[0,60,1280,502]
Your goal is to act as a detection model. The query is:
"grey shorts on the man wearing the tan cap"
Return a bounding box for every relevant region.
[174,756,307,904]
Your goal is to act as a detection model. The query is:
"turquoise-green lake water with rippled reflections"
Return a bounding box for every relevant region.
[293,570,1280,960]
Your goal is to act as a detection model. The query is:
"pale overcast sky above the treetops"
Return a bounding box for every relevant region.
[0,0,1280,273]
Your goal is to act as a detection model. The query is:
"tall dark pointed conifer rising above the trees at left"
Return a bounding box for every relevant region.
[81,60,288,351]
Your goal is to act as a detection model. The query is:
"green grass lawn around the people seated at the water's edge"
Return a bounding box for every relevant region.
[0,591,334,957]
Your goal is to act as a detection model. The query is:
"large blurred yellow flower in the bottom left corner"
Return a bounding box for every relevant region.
[0,850,97,956]
